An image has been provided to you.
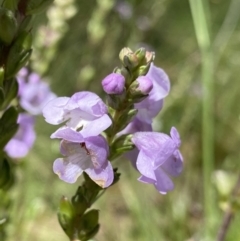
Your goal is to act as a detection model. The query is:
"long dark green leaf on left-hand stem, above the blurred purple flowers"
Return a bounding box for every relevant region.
[5,31,32,79]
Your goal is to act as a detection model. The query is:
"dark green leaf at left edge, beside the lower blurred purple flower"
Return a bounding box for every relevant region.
[0,107,18,149]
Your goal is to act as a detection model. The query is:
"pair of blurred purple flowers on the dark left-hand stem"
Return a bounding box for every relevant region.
[5,68,56,159]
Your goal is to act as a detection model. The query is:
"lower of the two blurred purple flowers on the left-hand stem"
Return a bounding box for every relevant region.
[5,114,36,158]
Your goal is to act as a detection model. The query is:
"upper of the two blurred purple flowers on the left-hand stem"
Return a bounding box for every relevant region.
[17,68,56,115]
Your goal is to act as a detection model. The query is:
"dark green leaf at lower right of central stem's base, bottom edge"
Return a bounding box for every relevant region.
[78,209,99,241]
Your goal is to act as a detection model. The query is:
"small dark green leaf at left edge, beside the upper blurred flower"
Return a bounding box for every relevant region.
[2,78,18,109]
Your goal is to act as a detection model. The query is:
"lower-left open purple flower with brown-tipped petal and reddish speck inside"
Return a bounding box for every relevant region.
[53,128,114,188]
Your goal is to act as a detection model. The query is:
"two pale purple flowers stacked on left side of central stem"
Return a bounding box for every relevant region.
[43,91,113,188]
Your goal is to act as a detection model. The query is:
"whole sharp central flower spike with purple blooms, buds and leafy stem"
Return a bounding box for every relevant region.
[43,48,183,240]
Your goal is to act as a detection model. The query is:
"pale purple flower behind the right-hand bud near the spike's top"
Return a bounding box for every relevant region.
[134,64,170,123]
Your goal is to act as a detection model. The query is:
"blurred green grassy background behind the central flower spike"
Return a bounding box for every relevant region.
[3,0,240,241]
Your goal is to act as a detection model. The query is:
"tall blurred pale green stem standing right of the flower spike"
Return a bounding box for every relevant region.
[189,0,216,236]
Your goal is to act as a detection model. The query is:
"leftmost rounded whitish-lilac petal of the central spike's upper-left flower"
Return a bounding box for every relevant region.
[43,97,70,125]
